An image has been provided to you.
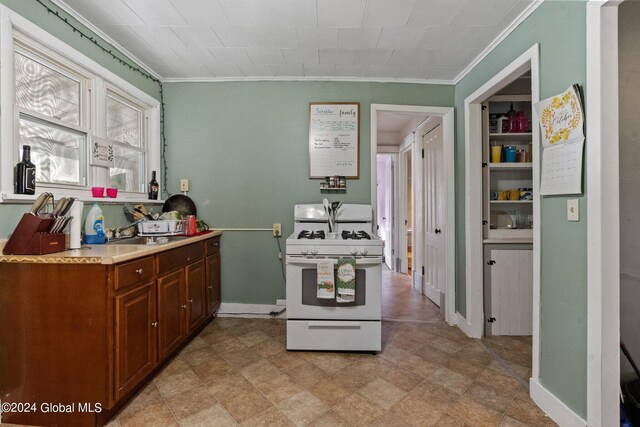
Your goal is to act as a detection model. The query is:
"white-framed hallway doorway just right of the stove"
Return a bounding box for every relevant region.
[371,104,456,324]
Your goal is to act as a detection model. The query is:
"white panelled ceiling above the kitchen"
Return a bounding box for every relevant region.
[54,0,540,82]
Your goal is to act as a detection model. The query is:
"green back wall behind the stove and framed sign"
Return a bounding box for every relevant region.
[165,82,454,304]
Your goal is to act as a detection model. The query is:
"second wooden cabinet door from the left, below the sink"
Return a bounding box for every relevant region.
[158,268,187,360]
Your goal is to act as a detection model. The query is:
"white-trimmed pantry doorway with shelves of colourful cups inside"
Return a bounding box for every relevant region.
[458,44,542,400]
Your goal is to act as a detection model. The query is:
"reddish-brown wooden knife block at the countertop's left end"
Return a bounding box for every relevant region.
[2,213,65,255]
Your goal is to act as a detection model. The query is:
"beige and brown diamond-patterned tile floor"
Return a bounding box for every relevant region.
[109,271,555,427]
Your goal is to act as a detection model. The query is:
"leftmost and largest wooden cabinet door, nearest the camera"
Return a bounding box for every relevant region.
[115,282,157,400]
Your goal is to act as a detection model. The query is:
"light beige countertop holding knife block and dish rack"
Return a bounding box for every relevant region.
[0,230,222,264]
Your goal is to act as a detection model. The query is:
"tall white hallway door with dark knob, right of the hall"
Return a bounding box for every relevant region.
[422,125,447,306]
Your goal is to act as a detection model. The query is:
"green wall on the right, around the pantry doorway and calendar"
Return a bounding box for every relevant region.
[455,1,588,417]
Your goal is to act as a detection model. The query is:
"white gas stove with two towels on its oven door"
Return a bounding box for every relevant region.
[286,204,382,351]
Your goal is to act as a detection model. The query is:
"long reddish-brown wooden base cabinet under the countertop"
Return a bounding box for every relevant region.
[0,236,220,426]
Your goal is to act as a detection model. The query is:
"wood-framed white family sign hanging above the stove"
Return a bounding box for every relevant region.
[309,102,360,178]
